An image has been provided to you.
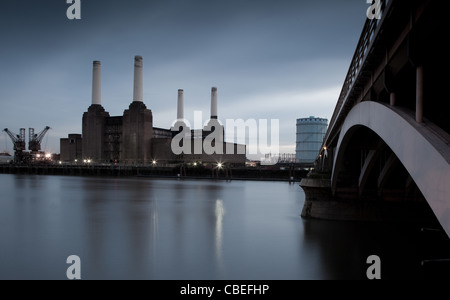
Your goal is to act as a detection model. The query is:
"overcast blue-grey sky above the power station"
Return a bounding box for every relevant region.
[0,0,368,153]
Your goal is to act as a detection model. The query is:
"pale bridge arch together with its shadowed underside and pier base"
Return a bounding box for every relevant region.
[302,101,450,234]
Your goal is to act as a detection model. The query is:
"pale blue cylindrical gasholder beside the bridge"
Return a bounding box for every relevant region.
[296,117,328,164]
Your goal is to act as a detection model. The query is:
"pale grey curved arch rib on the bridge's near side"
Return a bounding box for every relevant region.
[331,101,450,236]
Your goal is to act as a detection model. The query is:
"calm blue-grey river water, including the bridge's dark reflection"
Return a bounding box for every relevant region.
[0,175,428,280]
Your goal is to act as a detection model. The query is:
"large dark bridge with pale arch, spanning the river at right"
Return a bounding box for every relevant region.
[301,0,450,236]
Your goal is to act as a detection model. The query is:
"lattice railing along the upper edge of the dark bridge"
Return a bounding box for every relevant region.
[324,0,394,143]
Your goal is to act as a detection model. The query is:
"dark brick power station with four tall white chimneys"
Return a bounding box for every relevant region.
[61,56,246,165]
